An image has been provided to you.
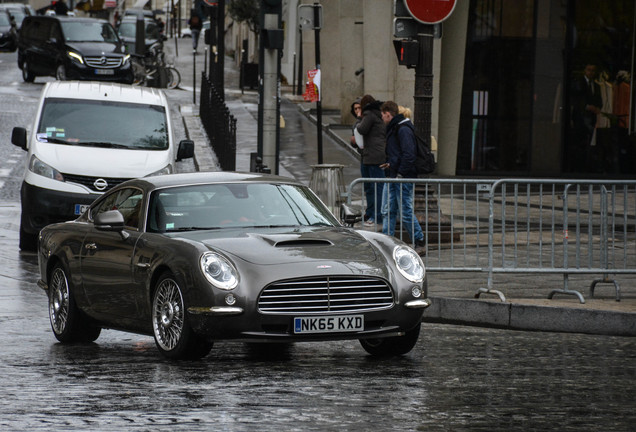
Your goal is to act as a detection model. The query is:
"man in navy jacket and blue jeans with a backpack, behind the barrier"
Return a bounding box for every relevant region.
[380,101,425,247]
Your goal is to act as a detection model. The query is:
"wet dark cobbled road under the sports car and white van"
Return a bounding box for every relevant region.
[0,49,636,431]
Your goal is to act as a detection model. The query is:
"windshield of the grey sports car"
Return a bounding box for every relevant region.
[147,183,339,232]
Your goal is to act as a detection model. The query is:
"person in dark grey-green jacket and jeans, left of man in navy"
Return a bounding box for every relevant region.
[356,95,386,227]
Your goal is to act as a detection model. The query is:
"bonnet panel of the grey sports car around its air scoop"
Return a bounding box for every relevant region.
[199,228,377,265]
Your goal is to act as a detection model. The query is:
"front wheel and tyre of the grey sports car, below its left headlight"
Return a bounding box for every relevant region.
[152,273,212,360]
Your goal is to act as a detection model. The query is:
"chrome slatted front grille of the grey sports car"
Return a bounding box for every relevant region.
[258,276,393,314]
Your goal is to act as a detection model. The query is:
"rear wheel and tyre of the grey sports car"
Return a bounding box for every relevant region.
[49,264,102,343]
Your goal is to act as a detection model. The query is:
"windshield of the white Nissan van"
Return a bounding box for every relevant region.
[37,98,169,150]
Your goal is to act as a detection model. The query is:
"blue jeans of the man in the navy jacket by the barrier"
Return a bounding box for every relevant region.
[382,183,424,242]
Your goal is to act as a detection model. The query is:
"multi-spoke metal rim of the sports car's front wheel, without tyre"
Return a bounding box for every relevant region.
[152,278,185,351]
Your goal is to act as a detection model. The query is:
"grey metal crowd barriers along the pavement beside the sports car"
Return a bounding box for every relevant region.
[345,178,636,303]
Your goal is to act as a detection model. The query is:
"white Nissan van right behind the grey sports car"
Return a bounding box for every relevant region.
[11,81,194,250]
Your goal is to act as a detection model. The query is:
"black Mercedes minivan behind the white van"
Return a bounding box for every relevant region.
[18,16,133,84]
